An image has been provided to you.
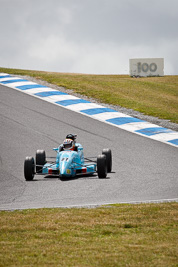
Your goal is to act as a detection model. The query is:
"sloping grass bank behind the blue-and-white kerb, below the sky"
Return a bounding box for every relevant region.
[0,68,178,123]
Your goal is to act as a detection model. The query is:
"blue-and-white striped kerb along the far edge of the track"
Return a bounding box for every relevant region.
[0,73,178,147]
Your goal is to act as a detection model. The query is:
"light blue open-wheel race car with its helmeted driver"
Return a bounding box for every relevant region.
[24,134,112,181]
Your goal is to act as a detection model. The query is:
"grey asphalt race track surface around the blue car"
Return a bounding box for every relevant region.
[0,86,178,210]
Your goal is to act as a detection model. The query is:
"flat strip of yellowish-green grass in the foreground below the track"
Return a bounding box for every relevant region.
[0,203,178,267]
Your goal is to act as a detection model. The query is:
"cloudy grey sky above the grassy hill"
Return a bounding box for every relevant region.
[0,0,178,75]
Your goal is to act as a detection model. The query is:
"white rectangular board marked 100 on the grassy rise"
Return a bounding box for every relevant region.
[129,58,164,77]
